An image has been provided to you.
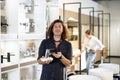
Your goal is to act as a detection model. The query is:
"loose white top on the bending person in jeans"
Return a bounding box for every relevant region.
[82,36,105,50]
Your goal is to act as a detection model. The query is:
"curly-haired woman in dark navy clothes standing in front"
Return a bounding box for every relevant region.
[37,19,72,80]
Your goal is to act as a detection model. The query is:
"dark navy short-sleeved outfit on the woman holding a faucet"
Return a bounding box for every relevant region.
[38,39,72,80]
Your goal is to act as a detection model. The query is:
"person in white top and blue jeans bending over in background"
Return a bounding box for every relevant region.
[77,29,104,74]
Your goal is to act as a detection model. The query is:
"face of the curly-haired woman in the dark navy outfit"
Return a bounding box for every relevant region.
[53,22,63,36]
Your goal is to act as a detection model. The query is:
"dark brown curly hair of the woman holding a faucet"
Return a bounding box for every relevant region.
[47,19,68,39]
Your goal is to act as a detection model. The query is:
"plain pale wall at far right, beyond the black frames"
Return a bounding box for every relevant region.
[108,1,120,56]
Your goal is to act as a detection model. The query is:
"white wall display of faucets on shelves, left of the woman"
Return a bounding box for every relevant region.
[0,0,59,80]
